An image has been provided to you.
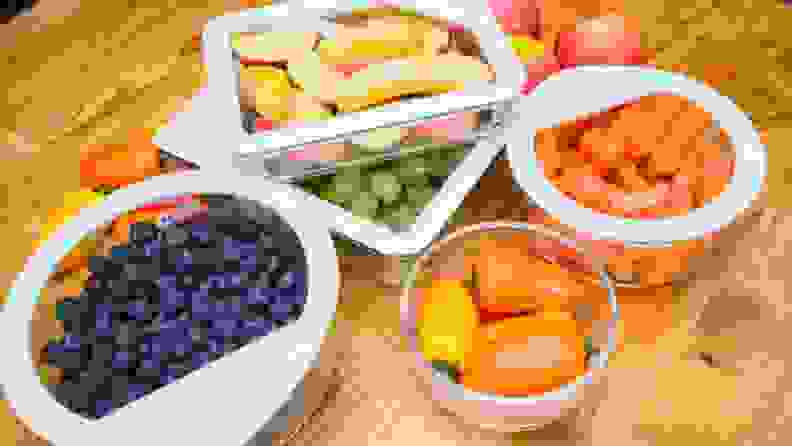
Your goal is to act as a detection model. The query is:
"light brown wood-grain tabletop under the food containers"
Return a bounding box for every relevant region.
[0,0,792,446]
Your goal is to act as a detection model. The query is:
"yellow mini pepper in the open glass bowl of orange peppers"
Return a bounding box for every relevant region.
[416,280,478,368]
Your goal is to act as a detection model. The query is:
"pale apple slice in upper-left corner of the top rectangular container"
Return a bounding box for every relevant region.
[231,31,319,65]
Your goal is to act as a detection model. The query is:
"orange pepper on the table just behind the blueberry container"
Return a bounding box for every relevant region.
[80,130,161,189]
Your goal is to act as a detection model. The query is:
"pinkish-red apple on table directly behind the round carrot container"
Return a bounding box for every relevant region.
[558,15,646,67]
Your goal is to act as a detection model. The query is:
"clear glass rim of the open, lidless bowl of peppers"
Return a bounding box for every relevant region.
[401,221,620,407]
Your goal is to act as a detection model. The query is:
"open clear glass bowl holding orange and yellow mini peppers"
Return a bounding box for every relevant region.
[401,222,619,432]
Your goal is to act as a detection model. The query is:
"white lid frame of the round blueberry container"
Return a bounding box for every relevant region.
[0,172,339,446]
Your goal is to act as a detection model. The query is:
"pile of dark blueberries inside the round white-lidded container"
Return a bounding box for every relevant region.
[44,199,307,418]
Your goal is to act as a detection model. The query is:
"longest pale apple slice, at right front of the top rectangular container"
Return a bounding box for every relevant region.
[333,53,493,112]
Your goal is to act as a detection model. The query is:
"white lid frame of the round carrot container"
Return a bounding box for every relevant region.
[505,66,767,246]
